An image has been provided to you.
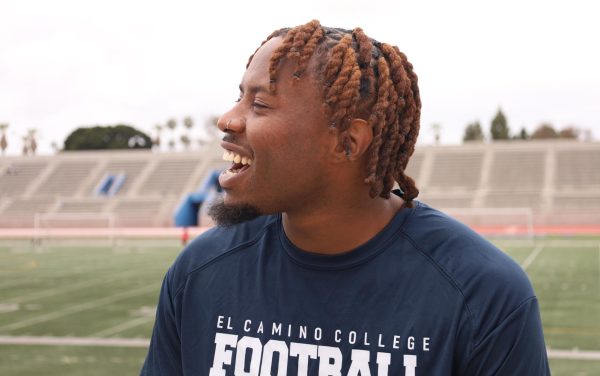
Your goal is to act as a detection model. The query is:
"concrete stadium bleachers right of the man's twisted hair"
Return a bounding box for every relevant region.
[407,140,600,225]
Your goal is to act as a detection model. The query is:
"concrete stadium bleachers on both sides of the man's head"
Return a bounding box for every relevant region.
[0,140,600,227]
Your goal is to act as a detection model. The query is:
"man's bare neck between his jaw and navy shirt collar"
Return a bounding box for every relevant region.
[283,194,404,255]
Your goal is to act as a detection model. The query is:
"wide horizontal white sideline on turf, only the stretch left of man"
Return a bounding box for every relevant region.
[0,336,150,348]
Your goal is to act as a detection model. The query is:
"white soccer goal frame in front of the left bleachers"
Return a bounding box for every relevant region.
[33,213,115,246]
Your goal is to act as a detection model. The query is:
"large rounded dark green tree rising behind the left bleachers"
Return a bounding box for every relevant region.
[64,124,152,151]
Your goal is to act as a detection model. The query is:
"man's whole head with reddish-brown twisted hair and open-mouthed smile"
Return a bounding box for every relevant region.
[213,20,421,223]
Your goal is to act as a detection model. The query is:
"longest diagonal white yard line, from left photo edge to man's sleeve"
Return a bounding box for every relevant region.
[0,285,159,331]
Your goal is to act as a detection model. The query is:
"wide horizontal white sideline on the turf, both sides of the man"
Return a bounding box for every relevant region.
[0,336,600,360]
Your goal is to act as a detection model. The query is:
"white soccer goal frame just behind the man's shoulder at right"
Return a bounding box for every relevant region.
[440,207,535,239]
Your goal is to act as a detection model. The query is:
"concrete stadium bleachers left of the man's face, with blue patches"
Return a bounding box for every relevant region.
[0,145,226,227]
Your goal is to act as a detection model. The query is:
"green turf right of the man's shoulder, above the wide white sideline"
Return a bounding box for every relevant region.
[499,239,600,351]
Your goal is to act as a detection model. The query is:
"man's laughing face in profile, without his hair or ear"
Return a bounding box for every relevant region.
[214,38,336,220]
